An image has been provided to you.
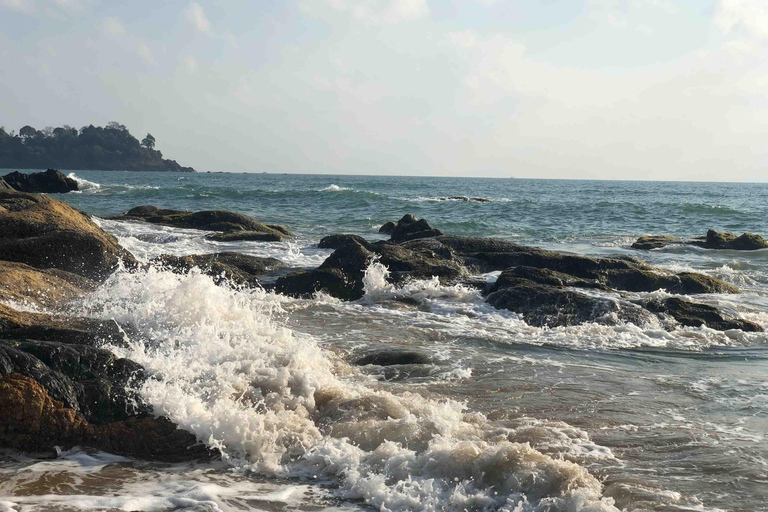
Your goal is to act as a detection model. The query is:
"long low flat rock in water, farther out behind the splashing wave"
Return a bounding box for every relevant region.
[113,206,291,240]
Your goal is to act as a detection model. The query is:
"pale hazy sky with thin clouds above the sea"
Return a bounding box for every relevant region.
[0,0,768,182]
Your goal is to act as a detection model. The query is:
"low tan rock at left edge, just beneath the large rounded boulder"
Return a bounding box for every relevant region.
[0,261,96,308]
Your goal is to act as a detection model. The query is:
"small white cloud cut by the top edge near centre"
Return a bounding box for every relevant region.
[300,0,429,24]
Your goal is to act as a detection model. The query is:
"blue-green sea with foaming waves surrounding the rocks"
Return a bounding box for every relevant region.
[0,171,768,512]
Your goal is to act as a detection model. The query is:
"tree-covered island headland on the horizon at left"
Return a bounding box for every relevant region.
[0,122,195,172]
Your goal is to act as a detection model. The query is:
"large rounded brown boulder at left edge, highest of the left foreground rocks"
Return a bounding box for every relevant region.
[0,191,137,281]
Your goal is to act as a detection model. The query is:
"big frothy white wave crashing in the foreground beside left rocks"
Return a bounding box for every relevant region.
[76,265,617,512]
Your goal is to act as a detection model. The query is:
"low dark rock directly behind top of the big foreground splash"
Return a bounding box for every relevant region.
[150,252,286,286]
